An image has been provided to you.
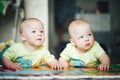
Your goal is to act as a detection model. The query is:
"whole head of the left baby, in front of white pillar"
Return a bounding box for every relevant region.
[20,18,45,46]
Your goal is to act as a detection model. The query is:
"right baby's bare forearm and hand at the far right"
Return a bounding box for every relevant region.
[98,53,110,70]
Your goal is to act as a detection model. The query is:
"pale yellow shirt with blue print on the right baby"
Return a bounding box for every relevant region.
[60,41,105,67]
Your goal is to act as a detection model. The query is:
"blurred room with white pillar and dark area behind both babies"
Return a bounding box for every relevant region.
[0,0,120,64]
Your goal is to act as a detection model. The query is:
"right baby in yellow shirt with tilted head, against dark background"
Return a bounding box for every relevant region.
[59,20,110,70]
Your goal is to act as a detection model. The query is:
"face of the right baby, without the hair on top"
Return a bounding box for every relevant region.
[71,24,94,52]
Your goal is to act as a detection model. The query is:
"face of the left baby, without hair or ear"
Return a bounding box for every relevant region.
[23,21,45,47]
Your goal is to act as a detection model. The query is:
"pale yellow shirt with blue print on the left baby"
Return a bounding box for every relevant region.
[3,43,54,67]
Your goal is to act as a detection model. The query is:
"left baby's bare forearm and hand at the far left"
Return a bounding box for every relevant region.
[2,56,22,70]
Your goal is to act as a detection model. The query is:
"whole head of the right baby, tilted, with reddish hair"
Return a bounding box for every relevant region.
[68,20,94,52]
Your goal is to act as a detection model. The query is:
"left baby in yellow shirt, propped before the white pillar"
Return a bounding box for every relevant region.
[2,18,59,70]
